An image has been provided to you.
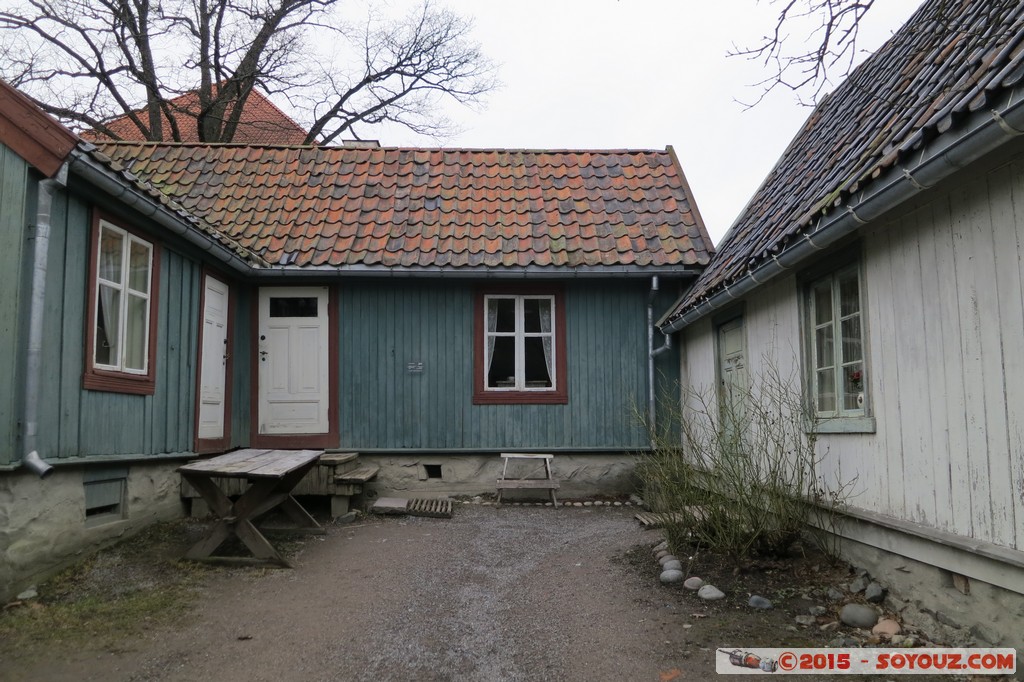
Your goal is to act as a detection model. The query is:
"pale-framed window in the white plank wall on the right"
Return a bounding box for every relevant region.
[807,264,866,420]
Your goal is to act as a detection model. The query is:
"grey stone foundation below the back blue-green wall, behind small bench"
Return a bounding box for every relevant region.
[359,453,638,501]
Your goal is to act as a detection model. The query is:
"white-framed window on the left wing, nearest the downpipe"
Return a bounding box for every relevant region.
[93,221,153,375]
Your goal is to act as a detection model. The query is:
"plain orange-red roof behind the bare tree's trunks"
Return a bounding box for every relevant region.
[82,90,306,144]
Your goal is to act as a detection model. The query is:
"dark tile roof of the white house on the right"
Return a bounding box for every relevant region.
[663,0,1024,324]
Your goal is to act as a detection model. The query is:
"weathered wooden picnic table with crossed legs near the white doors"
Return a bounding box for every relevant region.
[178,449,324,568]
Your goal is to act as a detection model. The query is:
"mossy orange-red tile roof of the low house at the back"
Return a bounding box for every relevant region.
[90,142,712,271]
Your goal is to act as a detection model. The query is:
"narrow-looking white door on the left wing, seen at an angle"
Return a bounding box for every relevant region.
[199,276,228,438]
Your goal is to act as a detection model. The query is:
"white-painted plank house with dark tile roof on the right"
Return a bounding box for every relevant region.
[659,0,1024,647]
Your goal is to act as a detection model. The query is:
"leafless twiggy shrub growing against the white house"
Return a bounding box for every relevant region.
[638,363,850,559]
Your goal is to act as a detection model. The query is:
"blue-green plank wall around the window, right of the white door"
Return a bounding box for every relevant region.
[339,282,647,450]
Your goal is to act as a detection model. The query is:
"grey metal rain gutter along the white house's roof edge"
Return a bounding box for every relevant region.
[662,87,1024,334]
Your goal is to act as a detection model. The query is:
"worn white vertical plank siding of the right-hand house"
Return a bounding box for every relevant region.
[683,151,1024,550]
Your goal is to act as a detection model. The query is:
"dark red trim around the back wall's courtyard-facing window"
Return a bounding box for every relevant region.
[473,285,569,404]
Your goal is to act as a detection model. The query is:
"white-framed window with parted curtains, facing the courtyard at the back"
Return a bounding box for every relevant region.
[483,296,557,391]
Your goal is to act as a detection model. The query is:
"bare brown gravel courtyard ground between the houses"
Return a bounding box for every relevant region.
[6,505,715,682]
